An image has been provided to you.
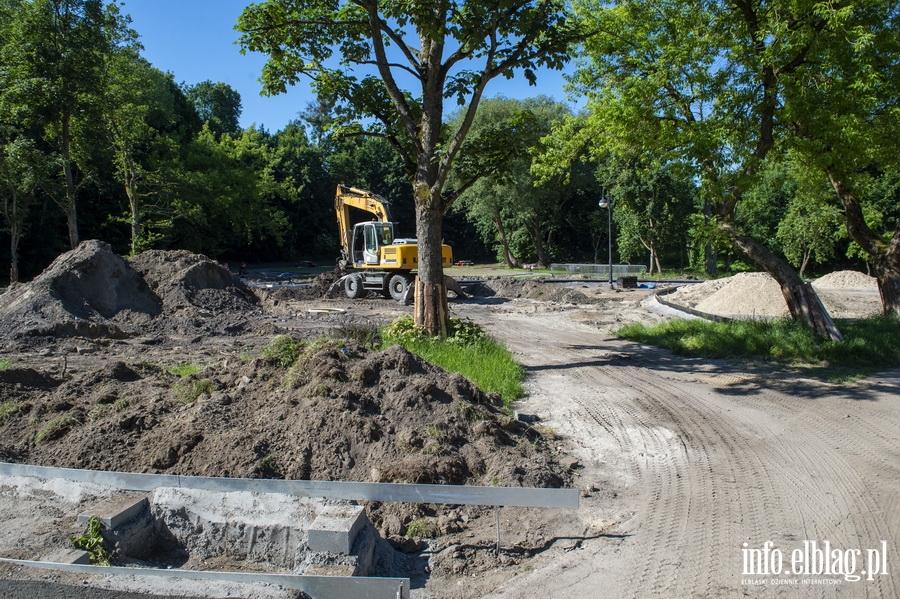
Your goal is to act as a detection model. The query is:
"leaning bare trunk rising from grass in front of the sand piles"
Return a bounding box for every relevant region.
[720,224,844,341]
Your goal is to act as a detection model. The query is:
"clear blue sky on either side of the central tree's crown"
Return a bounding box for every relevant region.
[119,0,566,132]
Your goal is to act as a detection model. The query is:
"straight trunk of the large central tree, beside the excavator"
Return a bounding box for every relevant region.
[414,183,449,337]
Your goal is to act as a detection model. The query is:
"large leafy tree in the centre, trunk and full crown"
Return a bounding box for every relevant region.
[238,0,579,335]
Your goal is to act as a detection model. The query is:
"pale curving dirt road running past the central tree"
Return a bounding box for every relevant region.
[460,308,900,598]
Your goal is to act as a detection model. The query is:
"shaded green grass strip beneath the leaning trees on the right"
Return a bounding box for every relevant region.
[616,315,900,378]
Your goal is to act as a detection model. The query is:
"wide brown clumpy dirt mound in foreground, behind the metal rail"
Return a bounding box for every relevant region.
[0,340,565,528]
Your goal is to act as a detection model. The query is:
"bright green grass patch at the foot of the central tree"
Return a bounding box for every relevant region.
[381,316,525,406]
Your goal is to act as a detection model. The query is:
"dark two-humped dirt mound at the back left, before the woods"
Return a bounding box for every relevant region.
[0,240,258,339]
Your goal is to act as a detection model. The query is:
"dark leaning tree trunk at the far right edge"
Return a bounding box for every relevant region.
[825,169,900,316]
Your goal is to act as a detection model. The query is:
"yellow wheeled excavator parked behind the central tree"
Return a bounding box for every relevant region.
[334,185,453,301]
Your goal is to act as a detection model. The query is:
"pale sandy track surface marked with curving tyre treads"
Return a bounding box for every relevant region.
[474,315,900,597]
